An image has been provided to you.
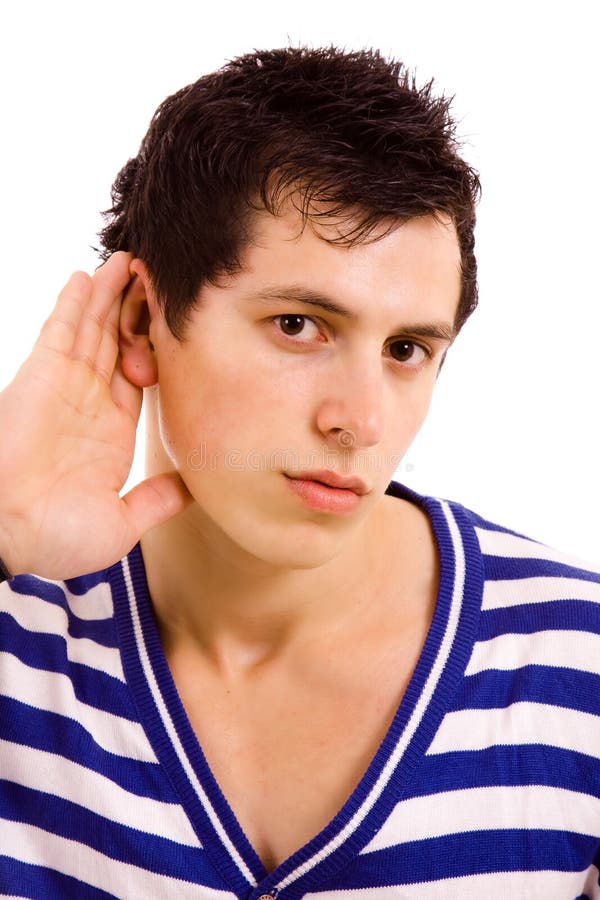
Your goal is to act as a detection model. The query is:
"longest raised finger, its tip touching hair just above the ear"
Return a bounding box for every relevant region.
[71,251,132,366]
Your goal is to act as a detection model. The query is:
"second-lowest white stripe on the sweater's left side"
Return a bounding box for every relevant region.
[0,740,200,847]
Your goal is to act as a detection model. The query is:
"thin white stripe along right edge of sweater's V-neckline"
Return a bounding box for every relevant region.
[277,501,465,890]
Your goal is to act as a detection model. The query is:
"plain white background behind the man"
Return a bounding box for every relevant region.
[0,0,600,561]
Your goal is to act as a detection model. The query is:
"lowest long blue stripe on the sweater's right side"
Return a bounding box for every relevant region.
[342,829,598,889]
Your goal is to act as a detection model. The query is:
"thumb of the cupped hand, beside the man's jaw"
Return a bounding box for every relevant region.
[122,472,194,540]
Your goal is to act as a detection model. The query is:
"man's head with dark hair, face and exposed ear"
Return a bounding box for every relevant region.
[111,50,478,571]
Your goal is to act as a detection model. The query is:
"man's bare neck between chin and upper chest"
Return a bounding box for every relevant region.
[142,505,394,666]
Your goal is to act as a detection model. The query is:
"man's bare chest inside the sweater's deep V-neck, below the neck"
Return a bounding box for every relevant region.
[169,632,420,871]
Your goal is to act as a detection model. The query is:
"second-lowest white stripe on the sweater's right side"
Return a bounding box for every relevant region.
[361,785,600,853]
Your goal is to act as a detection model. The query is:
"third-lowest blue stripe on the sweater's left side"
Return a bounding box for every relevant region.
[0,696,173,803]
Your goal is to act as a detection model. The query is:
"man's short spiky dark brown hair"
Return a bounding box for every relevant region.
[100,47,480,338]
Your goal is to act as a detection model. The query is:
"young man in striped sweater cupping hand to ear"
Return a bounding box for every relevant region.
[0,49,600,900]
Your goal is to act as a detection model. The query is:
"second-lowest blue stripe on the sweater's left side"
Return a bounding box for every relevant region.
[0,782,223,888]
